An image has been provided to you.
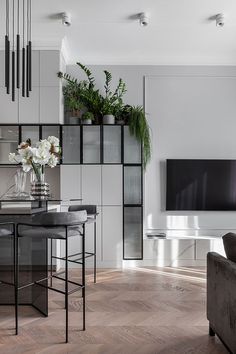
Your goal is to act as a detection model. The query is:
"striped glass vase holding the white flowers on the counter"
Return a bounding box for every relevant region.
[30,166,50,200]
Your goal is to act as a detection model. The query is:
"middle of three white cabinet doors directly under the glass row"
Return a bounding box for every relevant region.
[81,165,102,205]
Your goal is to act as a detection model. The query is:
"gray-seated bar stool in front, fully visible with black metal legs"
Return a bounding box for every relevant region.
[16,211,87,343]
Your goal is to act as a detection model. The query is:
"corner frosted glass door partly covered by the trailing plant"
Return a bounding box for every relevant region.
[124,126,141,163]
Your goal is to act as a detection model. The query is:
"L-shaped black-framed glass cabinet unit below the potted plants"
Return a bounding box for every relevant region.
[0,124,143,260]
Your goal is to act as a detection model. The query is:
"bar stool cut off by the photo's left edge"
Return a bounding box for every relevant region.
[0,222,17,334]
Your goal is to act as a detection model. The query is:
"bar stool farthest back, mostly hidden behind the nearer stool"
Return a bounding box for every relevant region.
[68,205,98,283]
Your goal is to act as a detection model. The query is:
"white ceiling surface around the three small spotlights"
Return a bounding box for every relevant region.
[0,0,236,65]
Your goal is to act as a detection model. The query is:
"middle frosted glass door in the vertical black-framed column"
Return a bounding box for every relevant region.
[124,166,142,204]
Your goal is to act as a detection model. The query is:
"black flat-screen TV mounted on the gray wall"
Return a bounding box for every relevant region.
[166,160,236,210]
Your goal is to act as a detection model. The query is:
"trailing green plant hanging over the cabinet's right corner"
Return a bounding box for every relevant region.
[128,106,151,169]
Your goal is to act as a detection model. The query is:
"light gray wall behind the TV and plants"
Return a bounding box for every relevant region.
[67,65,236,235]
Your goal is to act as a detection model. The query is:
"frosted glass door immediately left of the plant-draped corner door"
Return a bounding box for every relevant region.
[103,125,121,163]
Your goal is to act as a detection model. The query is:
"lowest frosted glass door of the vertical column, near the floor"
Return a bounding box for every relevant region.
[124,207,143,259]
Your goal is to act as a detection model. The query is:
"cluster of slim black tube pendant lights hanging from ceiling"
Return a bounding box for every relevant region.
[5,0,32,101]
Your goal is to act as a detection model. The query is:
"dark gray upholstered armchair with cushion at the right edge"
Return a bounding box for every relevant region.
[207,233,236,354]
